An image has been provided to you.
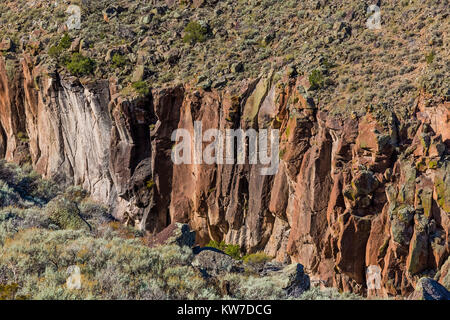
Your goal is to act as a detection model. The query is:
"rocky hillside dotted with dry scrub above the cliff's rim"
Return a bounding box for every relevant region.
[0,0,449,115]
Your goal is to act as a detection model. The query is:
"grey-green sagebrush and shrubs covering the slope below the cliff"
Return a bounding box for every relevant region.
[0,161,358,300]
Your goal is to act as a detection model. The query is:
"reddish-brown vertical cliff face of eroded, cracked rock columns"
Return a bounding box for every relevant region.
[0,56,450,295]
